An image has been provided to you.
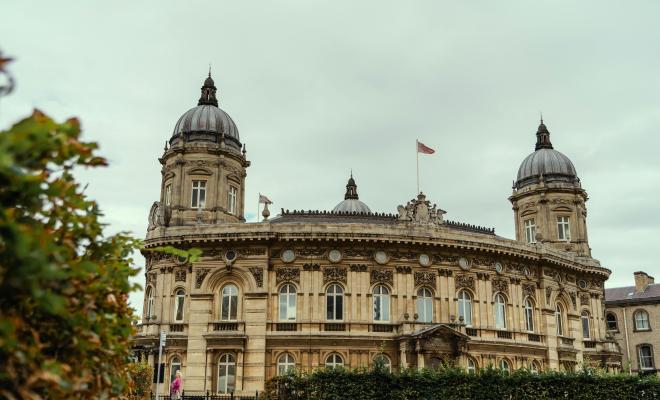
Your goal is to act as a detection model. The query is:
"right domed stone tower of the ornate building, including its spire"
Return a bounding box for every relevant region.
[509,119,591,256]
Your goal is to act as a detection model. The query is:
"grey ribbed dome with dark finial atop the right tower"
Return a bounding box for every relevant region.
[515,120,579,189]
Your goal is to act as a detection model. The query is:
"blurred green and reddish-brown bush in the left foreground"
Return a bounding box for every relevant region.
[0,111,139,399]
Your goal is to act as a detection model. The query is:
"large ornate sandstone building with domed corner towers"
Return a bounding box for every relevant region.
[133,76,621,393]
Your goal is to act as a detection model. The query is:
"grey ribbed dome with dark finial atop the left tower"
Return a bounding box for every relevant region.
[170,74,241,150]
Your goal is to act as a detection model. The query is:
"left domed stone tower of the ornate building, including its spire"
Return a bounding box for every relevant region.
[149,72,250,229]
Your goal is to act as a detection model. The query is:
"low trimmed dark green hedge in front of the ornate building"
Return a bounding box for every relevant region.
[266,368,660,400]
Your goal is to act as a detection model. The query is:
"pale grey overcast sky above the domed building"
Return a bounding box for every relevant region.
[0,0,660,310]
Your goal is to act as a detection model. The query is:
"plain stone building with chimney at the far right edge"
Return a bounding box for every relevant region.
[605,271,660,374]
